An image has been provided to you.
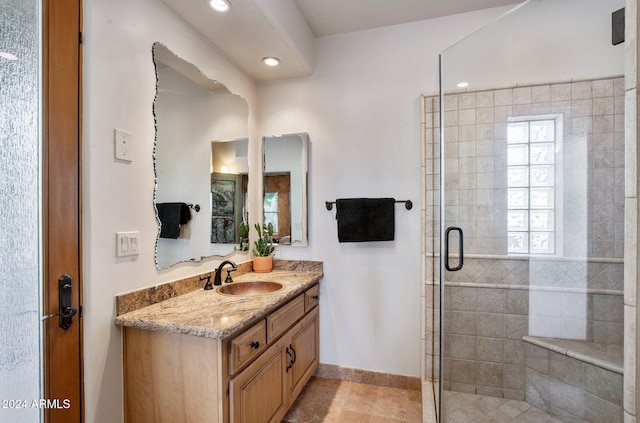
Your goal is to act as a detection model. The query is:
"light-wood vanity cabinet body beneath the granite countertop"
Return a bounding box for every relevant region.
[123,284,319,423]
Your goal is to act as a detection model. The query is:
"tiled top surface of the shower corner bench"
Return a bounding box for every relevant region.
[522,336,624,375]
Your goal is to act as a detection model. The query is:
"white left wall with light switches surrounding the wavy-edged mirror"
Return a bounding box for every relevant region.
[83,0,260,423]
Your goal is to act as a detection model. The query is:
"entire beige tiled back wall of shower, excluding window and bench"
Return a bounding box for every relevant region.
[423,77,625,399]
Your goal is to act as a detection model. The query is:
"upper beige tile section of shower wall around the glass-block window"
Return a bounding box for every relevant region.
[425,78,625,258]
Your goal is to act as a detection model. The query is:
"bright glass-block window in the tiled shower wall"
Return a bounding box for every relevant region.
[507,118,559,254]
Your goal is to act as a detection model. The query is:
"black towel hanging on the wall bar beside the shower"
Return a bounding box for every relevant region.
[336,198,396,242]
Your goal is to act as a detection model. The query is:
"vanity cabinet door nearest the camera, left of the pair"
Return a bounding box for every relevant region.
[229,341,289,423]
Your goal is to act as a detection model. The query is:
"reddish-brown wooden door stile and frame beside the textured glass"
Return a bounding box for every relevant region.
[42,0,83,423]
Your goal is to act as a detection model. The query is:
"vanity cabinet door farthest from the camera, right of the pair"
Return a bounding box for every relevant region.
[287,307,318,404]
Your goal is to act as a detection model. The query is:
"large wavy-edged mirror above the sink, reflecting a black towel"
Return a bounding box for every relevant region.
[153,43,249,269]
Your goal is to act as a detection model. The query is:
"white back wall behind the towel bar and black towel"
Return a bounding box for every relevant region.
[258,8,509,376]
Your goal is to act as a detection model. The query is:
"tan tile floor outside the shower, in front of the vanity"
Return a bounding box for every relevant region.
[282,377,422,423]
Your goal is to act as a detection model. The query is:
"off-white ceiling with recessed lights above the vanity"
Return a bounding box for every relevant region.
[161,0,522,82]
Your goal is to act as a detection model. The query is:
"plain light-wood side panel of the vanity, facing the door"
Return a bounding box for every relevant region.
[123,327,222,423]
